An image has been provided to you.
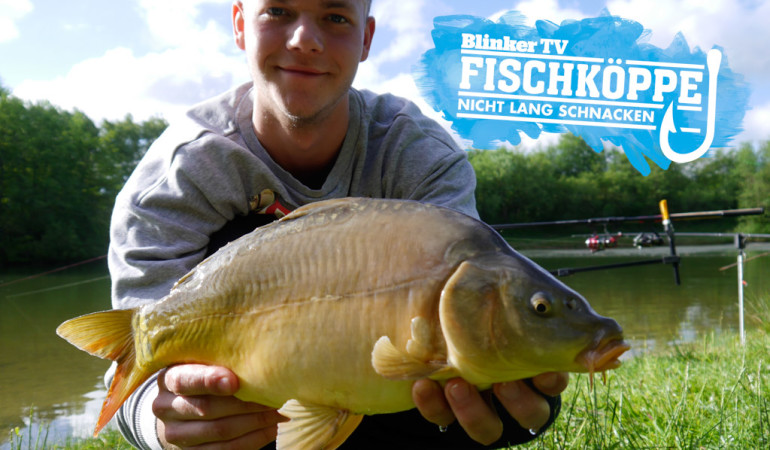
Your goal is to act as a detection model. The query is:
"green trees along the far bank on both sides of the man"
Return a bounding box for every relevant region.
[0,86,770,267]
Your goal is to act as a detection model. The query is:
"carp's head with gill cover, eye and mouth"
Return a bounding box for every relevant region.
[439,249,629,384]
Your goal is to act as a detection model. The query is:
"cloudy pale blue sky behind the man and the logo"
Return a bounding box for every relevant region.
[0,0,770,151]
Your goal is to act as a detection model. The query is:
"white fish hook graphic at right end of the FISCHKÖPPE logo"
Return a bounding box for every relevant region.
[660,48,722,163]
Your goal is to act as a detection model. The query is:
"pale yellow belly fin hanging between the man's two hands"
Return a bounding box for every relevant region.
[276,400,364,450]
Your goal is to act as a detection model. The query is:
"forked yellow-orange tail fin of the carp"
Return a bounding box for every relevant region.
[56,309,153,436]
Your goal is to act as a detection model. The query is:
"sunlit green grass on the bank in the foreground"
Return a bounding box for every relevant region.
[11,299,770,450]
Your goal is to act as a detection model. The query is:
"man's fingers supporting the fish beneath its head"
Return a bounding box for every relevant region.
[412,372,569,444]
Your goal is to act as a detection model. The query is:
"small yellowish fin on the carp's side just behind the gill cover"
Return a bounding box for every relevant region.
[372,336,457,380]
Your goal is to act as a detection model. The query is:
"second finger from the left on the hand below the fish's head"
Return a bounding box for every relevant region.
[444,378,503,445]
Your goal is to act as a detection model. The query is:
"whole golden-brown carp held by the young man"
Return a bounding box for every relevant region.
[57,198,629,450]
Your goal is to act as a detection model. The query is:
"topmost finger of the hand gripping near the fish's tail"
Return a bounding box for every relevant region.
[158,364,238,395]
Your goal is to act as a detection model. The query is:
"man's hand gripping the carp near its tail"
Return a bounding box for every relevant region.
[152,364,288,449]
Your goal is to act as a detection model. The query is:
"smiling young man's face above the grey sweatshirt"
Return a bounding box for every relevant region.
[233,0,374,123]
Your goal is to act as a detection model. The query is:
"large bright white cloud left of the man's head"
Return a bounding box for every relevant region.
[12,0,248,122]
